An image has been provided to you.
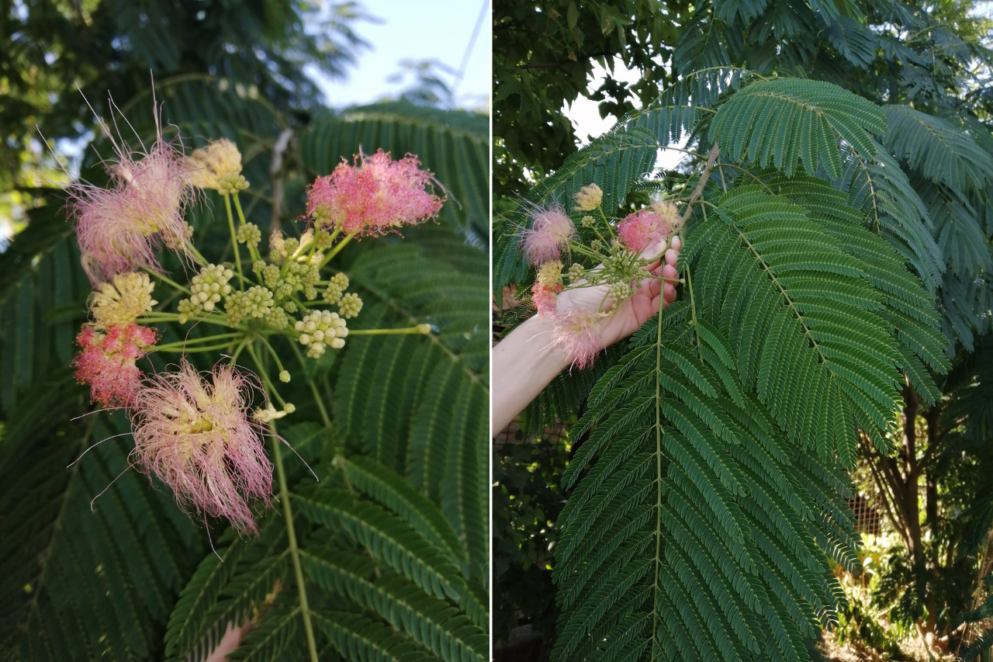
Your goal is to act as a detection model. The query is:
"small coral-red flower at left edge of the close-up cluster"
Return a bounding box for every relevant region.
[72,323,158,408]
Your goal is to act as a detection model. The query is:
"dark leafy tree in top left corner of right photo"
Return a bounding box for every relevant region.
[493,0,690,198]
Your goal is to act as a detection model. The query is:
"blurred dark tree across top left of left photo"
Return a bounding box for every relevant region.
[0,0,368,233]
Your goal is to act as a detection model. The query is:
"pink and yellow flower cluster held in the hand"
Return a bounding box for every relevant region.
[521,184,683,369]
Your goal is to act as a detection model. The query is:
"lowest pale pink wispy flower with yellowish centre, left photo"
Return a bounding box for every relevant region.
[132,359,272,533]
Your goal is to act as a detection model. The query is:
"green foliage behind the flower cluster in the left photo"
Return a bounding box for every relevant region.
[0,0,489,661]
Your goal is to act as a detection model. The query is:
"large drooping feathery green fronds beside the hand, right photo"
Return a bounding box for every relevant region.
[508,79,948,661]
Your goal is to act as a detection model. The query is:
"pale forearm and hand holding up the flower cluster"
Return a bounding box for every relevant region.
[491,238,678,436]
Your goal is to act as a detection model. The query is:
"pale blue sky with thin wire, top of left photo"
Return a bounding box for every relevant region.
[308,0,491,109]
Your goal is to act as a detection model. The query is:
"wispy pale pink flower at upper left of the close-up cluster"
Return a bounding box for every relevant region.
[69,138,193,285]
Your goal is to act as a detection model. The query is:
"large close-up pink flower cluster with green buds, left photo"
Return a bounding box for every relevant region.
[68,118,444,533]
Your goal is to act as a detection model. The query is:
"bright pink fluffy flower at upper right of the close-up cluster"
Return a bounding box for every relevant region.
[307,150,445,235]
